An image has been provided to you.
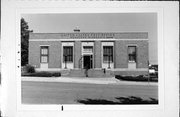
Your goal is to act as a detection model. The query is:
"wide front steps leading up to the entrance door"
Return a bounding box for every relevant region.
[62,69,114,78]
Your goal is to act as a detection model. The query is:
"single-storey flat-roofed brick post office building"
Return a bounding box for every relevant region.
[29,29,149,75]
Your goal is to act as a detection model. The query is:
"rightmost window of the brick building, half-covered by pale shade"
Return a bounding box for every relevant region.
[128,46,136,62]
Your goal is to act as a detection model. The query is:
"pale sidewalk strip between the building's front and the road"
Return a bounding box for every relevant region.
[21,77,158,86]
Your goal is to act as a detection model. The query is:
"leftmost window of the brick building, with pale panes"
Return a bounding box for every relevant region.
[41,46,49,63]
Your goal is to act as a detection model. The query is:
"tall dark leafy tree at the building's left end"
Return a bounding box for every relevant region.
[21,18,32,66]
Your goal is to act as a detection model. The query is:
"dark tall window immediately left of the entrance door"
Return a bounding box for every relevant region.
[63,46,73,62]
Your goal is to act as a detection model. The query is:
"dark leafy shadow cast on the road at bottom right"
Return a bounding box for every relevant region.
[77,96,158,105]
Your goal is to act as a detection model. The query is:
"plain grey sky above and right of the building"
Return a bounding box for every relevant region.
[22,13,158,64]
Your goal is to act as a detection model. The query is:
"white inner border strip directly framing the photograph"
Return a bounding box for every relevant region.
[16,4,164,110]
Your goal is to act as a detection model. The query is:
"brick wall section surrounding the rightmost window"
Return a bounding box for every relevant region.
[114,40,149,68]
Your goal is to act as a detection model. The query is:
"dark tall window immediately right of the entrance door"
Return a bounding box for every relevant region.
[103,46,113,62]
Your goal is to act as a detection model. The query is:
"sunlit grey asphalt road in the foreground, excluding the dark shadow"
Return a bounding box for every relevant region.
[22,81,158,104]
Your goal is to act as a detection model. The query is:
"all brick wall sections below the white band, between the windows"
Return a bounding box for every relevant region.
[29,40,149,68]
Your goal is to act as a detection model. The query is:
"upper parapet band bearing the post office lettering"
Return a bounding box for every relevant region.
[30,32,148,39]
